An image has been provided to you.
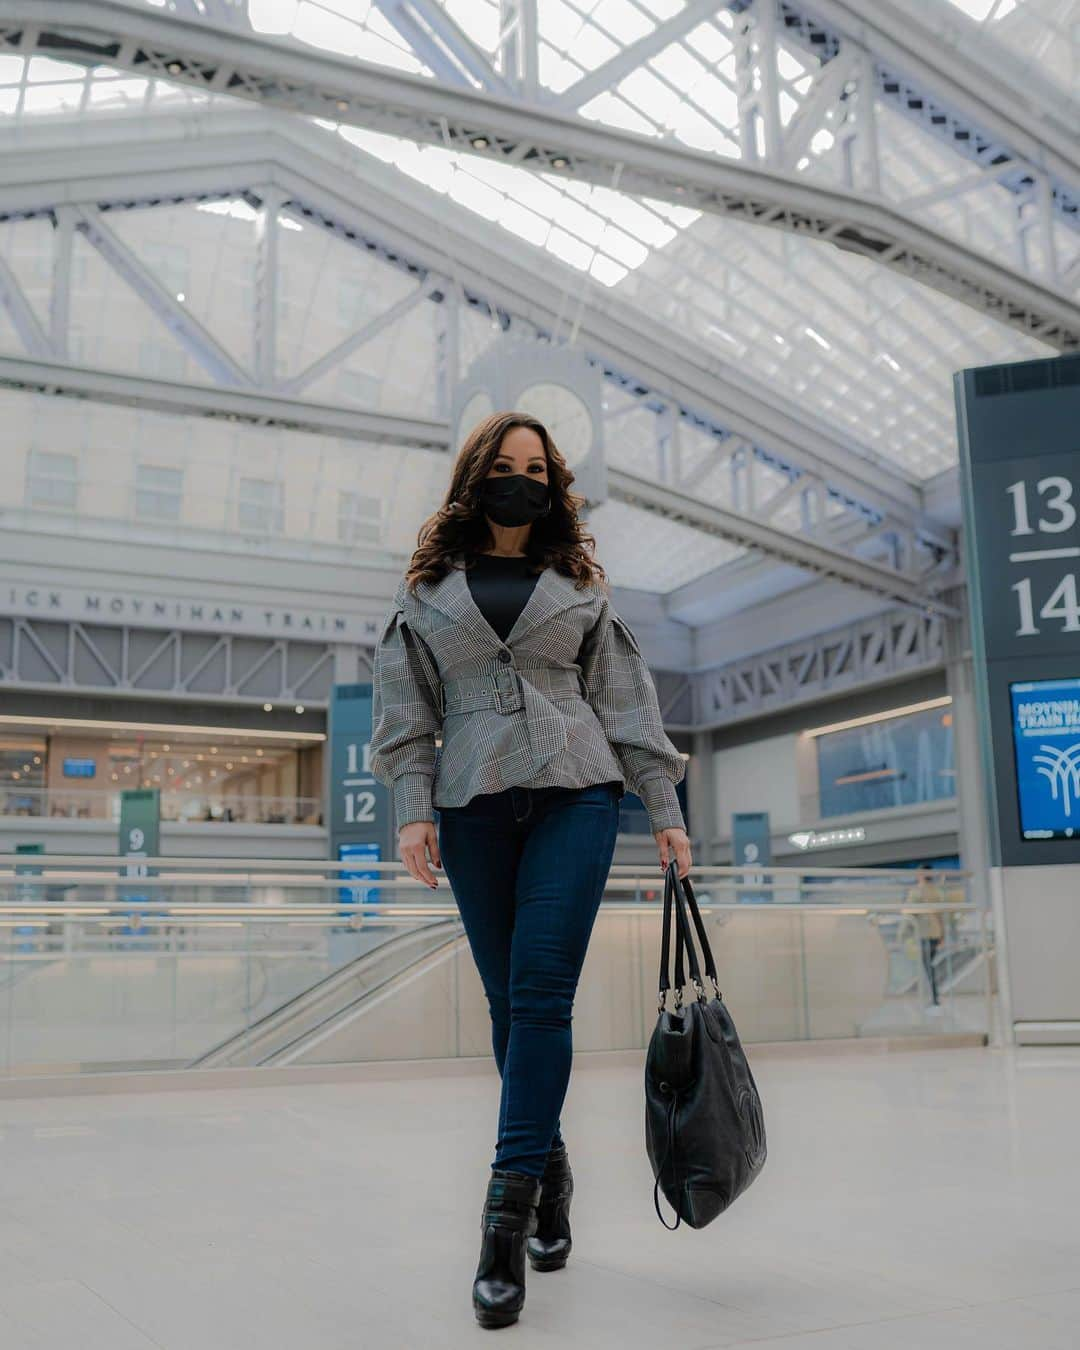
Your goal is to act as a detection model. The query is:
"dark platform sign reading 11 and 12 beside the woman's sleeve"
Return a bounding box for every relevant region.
[327,684,393,859]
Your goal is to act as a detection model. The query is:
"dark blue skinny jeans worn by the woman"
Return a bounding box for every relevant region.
[439,779,625,1176]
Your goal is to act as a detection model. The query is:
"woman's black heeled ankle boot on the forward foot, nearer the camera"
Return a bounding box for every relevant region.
[473,1168,540,1327]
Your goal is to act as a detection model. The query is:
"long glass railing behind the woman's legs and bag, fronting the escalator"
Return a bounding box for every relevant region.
[0,855,994,1075]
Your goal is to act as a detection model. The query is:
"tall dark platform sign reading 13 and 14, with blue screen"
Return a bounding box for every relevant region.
[956,356,1080,867]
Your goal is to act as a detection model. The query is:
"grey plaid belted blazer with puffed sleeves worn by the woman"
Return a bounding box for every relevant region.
[370,556,686,832]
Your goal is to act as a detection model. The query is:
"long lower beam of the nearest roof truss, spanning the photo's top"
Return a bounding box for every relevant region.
[0,0,1080,351]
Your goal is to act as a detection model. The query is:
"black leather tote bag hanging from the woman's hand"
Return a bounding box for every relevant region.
[645,859,765,1231]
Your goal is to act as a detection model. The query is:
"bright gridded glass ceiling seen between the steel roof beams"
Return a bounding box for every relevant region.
[0,0,1080,491]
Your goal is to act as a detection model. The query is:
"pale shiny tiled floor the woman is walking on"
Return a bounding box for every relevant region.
[0,1050,1080,1350]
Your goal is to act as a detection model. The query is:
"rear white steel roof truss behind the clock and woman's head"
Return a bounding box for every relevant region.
[0,117,956,606]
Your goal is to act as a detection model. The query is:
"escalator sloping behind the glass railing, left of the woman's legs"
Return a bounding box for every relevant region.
[186,918,464,1069]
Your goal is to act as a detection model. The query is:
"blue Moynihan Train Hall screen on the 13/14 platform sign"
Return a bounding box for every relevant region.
[1008,679,1080,840]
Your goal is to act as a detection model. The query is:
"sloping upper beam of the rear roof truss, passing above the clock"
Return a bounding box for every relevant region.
[0,112,929,528]
